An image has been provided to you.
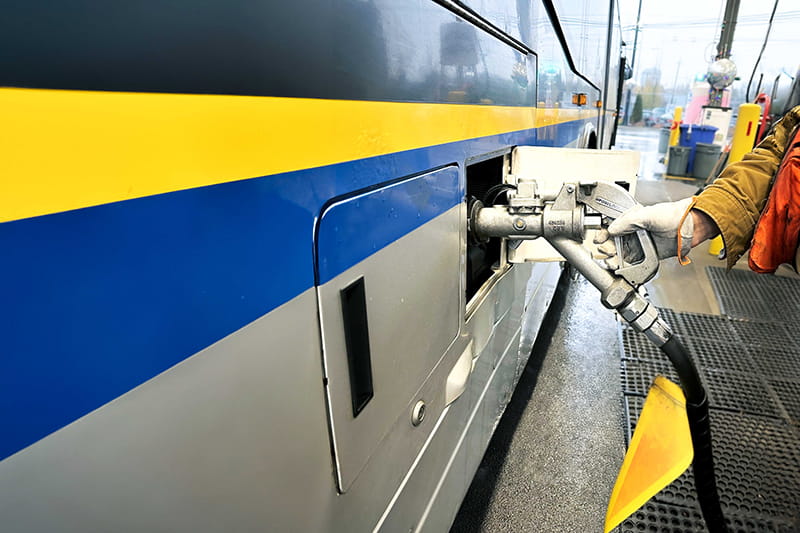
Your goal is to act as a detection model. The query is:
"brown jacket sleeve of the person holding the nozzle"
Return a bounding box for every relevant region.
[694,106,800,268]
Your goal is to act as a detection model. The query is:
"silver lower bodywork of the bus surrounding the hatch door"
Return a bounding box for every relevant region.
[0,252,560,533]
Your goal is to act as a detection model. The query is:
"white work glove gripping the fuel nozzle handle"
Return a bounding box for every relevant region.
[594,198,694,270]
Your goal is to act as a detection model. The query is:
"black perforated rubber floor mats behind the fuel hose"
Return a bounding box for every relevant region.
[619,290,800,533]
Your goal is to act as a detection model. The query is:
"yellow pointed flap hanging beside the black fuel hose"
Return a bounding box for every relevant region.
[605,376,694,533]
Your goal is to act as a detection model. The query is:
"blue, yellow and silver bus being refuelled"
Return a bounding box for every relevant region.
[0,0,620,532]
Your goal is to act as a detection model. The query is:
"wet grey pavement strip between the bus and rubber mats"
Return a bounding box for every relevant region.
[451,272,625,533]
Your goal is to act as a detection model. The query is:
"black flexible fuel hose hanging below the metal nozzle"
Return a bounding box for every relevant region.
[661,335,728,533]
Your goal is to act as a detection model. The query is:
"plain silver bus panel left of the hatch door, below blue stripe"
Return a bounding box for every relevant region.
[0,289,336,533]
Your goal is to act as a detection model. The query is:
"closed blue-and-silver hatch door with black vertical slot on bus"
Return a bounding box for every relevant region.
[315,166,472,495]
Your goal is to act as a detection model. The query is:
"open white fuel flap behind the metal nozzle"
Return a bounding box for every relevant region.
[506,146,640,263]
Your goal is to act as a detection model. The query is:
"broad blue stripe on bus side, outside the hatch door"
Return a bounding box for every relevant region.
[0,121,585,460]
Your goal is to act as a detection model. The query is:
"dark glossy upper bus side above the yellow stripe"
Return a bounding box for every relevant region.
[0,0,535,106]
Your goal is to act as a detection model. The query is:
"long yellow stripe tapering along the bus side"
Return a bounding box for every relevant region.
[0,88,598,222]
